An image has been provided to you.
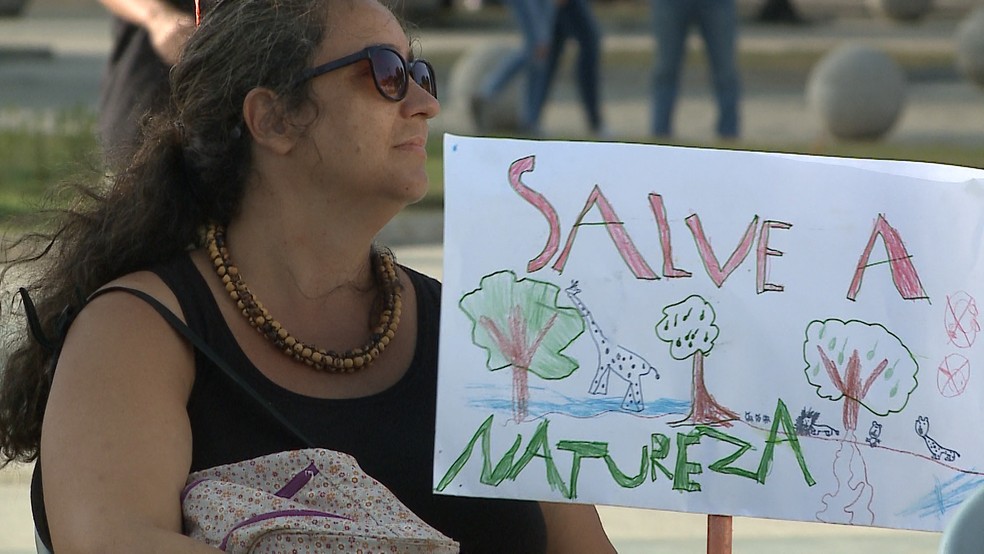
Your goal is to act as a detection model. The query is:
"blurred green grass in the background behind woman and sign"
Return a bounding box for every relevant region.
[0,110,984,223]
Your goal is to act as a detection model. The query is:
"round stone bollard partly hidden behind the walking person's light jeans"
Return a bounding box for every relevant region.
[448,43,526,133]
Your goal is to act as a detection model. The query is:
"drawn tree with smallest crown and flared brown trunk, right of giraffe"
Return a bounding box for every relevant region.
[656,294,738,427]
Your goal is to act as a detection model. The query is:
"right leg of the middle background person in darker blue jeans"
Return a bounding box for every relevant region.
[557,0,602,133]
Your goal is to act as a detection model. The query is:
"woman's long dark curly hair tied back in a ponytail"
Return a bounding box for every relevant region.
[0,0,338,467]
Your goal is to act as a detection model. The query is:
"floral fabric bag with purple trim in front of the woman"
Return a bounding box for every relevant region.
[181,448,458,554]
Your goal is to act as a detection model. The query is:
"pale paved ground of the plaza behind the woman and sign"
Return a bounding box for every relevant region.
[0,0,984,554]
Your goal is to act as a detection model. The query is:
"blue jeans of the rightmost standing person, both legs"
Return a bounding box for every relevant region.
[650,0,741,138]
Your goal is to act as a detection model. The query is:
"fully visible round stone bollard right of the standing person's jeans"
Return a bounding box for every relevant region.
[806,43,906,140]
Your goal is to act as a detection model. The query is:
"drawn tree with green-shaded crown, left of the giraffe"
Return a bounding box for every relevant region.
[458,271,584,421]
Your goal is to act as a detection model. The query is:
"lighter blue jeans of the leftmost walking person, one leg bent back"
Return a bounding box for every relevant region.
[481,0,554,129]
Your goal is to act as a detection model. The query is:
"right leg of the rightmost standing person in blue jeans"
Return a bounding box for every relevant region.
[690,0,741,138]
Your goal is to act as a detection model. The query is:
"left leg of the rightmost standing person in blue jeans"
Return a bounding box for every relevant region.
[650,0,699,137]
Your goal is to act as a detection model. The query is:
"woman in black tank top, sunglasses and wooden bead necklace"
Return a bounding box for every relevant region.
[0,0,612,554]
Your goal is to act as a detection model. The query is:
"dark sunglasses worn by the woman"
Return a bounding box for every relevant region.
[294,46,437,102]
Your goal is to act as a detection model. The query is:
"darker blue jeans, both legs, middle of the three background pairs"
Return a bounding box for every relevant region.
[531,0,602,131]
